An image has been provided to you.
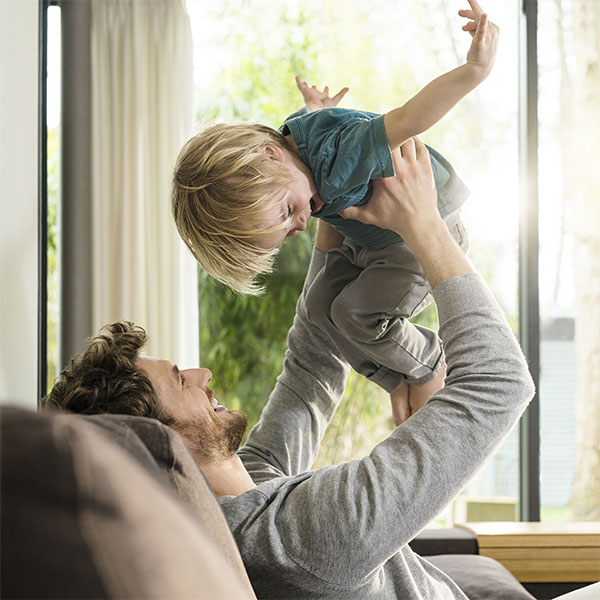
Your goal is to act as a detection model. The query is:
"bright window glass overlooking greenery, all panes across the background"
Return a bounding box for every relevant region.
[47,0,600,525]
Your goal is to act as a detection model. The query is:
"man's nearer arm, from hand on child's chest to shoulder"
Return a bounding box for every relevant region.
[248,140,533,586]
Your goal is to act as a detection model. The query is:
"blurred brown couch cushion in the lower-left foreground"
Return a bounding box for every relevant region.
[0,407,255,600]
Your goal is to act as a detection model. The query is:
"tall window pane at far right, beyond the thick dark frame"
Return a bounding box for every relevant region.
[538,0,600,521]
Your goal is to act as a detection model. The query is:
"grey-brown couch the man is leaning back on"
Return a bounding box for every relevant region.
[0,406,533,600]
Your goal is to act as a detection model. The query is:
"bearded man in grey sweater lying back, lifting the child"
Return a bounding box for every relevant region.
[47,140,533,600]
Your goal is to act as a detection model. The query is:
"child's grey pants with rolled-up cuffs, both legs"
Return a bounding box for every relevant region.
[306,213,468,392]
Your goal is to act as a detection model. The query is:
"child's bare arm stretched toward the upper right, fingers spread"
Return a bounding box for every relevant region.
[384,0,499,150]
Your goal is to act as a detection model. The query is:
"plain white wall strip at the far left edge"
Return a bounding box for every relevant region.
[0,0,39,407]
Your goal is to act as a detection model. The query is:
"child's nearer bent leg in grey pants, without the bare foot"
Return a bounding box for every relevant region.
[331,243,443,392]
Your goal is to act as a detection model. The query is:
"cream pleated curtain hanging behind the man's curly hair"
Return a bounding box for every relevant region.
[91,0,198,367]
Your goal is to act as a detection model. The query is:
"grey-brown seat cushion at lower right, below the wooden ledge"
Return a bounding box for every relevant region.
[426,554,535,600]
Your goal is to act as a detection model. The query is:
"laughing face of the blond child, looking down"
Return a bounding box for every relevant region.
[263,153,323,248]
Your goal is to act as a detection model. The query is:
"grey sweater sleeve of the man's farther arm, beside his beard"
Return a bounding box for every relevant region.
[238,249,350,483]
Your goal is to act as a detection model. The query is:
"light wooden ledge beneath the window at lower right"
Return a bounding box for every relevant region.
[457,522,600,583]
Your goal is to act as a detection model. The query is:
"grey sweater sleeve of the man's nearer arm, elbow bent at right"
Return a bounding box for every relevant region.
[268,274,534,585]
